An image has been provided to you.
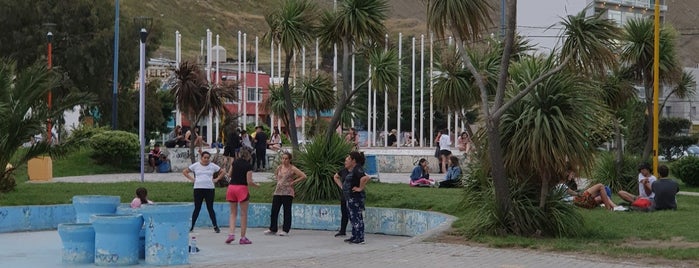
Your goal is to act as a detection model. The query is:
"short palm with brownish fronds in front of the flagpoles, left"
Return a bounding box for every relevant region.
[171,61,238,163]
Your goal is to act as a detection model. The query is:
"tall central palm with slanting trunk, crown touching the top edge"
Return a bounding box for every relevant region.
[319,0,398,140]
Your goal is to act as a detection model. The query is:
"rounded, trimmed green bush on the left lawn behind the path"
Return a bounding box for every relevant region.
[90,130,140,166]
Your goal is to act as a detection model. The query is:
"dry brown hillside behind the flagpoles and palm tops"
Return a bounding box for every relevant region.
[121,0,426,62]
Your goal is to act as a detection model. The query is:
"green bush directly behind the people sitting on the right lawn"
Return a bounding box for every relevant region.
[589,152,642,193]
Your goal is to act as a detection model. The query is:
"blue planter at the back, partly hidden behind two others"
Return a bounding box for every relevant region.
[73,195,121,223]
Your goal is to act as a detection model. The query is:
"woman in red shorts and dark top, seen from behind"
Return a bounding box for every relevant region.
[226,150,260,245]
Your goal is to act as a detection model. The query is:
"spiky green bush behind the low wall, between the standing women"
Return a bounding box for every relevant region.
[294,134,352,202]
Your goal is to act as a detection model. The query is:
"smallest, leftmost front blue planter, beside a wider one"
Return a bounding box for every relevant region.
[58,223,95,264]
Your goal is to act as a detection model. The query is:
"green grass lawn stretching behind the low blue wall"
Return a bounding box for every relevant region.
[0,151,699,266]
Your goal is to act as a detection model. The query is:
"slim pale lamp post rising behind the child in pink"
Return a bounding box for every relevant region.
[138,28,148,182]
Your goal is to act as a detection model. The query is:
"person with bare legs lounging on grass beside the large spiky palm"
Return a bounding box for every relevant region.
[554,169,627,211]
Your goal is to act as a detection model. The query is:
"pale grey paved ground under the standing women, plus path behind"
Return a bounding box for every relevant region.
[12,172,696,268]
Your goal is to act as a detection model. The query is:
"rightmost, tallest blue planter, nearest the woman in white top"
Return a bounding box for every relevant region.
[139,203,194,265]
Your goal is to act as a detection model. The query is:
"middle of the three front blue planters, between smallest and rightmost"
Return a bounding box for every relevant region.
[91,214,143,266]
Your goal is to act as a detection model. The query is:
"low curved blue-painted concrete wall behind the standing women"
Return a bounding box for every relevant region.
[0,203,453,236]
